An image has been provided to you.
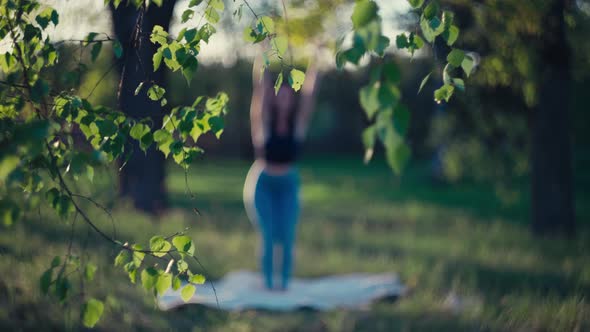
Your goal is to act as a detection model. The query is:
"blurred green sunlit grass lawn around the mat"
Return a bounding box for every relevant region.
[0,159,590,331]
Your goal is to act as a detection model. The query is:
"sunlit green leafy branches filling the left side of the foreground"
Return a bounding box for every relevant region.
[0,0,228,327]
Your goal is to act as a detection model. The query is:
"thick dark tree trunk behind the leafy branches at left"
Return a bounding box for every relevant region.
[111,0,176,213]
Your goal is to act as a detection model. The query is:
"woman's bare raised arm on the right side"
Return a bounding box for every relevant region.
[295,60,319,139]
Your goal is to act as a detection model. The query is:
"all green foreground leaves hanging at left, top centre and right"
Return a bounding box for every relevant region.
[0,0,474,327]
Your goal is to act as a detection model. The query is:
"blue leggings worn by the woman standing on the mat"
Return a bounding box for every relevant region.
[244,163,299,289]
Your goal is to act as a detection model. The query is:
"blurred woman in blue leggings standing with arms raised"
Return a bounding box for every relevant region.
[244,55,317,291]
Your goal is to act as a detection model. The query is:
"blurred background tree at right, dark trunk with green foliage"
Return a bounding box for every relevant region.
[414,0,588,234]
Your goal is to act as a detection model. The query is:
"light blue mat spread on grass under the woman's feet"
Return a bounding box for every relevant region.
[158,271,405,311]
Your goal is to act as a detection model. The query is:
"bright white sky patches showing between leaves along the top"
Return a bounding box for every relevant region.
[40,0,409,65]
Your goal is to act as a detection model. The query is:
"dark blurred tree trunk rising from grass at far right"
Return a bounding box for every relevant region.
[531,0,575,236]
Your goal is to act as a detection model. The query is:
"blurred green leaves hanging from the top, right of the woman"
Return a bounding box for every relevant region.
[336,0,474,174]
